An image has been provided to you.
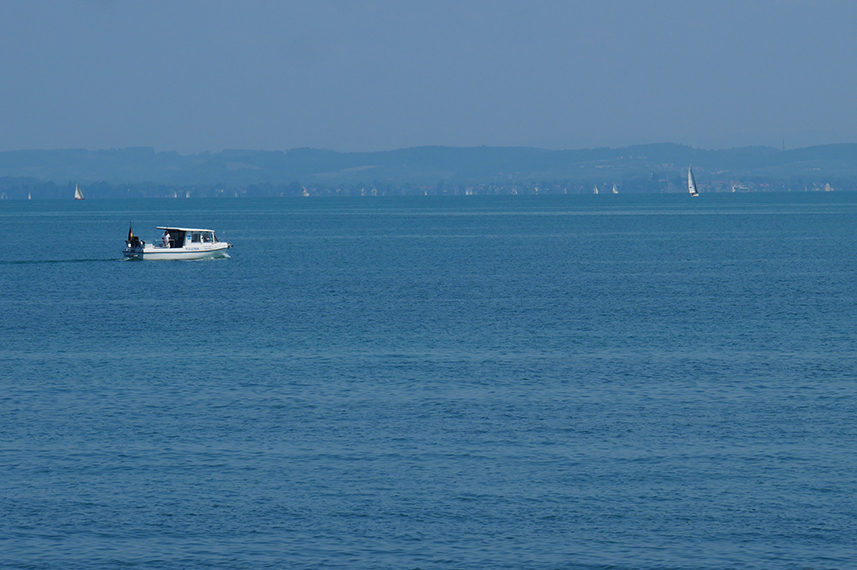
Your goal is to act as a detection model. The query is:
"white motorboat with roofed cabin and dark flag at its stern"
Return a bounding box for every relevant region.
[124,226,232,259]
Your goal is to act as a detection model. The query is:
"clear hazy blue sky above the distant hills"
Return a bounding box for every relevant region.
[0,0,857,154]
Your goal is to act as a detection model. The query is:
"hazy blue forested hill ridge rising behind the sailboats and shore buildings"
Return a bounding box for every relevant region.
[0,144,857,193]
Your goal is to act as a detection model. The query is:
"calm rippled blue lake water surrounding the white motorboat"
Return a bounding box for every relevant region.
[0,193,857,569]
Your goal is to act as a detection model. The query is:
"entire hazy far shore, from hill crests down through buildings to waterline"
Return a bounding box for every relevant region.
[0,143,857,199]
